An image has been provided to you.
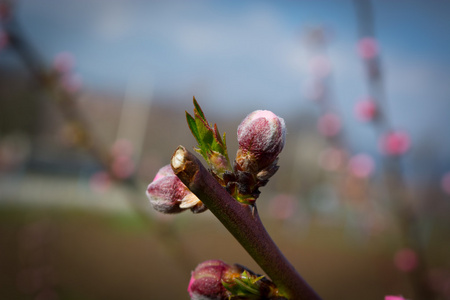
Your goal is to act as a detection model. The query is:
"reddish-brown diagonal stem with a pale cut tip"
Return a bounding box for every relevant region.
[171,146,321,300]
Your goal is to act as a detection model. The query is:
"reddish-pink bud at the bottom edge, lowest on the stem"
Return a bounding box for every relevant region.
[188,260,232,300]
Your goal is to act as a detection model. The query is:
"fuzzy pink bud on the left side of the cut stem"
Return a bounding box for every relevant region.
[146,165,206,214]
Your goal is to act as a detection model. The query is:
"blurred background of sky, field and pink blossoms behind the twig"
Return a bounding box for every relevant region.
[0,0,450,300]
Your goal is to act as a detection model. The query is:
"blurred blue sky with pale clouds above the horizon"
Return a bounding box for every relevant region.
[0,0,450,180]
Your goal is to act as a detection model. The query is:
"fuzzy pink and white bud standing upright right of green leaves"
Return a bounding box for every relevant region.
[236,110,286,173]
